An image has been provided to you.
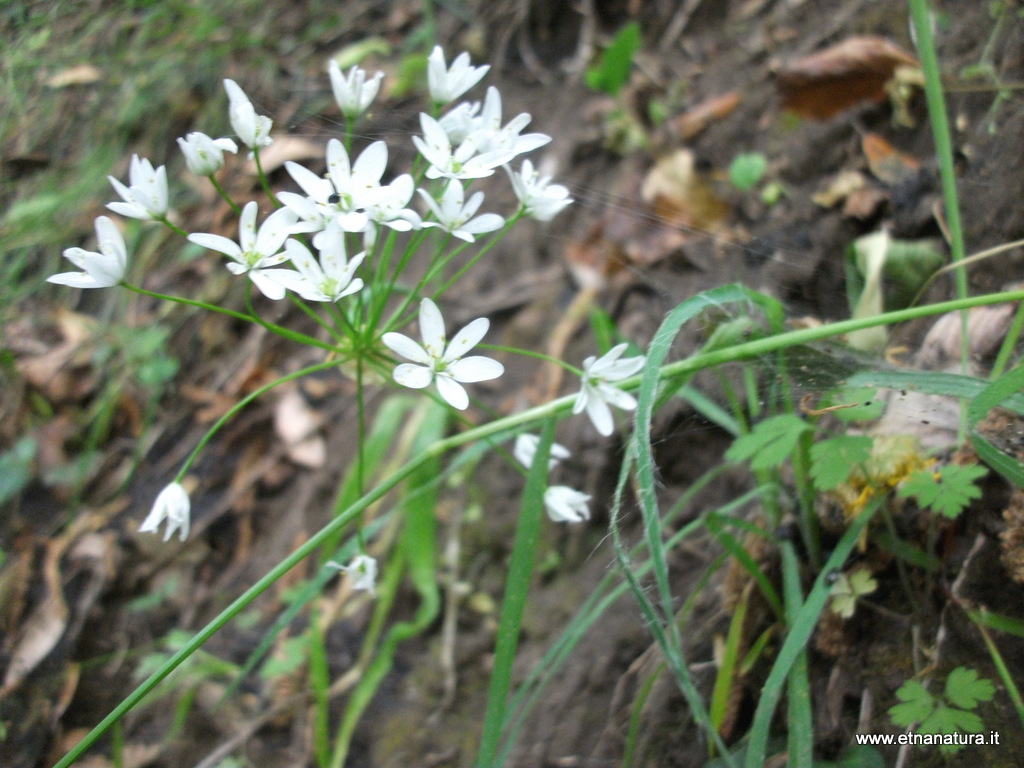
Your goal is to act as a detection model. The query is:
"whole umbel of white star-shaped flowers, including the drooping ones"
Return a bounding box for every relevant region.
[49,47,643,590]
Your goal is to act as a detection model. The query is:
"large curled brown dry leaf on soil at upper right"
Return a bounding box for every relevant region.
[776,37,919,120]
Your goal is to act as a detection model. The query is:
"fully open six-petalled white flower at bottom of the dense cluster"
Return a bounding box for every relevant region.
[381,299,505,411]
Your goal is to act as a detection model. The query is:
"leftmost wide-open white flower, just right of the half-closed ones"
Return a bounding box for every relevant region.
[188,201,295,299]
